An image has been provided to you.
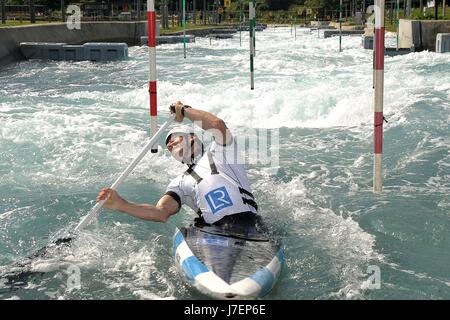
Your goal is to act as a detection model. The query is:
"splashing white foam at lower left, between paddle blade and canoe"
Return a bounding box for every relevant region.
[28,223,175,299]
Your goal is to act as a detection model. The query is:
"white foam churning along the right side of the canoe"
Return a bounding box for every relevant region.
[256,177,384,299]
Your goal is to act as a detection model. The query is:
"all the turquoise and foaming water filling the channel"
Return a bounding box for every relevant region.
[0,28,450,299]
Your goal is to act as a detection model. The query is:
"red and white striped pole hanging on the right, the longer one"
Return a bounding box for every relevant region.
[373,0,385,192]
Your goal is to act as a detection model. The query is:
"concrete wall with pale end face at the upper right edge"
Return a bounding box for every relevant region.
[399,19,450,51]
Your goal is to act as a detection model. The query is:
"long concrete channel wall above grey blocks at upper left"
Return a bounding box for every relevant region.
[0,21,147,66]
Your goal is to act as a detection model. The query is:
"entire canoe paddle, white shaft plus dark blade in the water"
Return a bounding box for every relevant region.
[0,115,175,290]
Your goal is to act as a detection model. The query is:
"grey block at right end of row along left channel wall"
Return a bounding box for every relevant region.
[83,42,128,61]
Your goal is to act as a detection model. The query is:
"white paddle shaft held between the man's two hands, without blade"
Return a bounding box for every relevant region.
[75,117,174,232]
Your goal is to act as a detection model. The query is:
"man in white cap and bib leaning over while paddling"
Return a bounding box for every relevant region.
[96,101,259,234]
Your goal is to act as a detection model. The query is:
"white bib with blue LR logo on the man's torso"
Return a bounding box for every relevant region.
[186,151,258,224]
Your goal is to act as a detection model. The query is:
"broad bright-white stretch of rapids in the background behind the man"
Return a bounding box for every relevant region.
[148,28,449,128]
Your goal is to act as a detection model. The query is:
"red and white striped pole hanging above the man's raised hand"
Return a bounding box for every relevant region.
[147,0,158,153]
